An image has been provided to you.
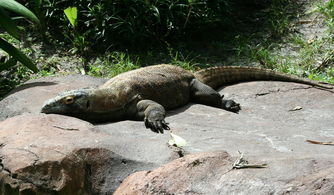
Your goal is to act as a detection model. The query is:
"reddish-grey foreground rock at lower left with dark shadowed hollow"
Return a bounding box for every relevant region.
[0,114,178,194]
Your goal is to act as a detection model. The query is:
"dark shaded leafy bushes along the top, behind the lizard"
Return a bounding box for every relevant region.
[24,0,230,49]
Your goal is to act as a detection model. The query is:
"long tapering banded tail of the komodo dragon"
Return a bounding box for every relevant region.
[194,66,333,89]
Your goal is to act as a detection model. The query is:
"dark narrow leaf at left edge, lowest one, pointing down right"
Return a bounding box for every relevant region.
[0,37,38,72]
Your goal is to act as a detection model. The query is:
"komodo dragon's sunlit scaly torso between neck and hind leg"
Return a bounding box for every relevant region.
[99,65,194,110]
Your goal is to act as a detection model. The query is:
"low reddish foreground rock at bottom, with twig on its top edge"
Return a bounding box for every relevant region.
[114,151,334,195]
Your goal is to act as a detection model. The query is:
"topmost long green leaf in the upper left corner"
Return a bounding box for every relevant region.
[0,0,39,24]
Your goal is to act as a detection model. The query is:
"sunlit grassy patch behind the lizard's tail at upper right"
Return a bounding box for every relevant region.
[223,0,334,83]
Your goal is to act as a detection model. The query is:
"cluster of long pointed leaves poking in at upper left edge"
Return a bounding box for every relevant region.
[0,0,39,72]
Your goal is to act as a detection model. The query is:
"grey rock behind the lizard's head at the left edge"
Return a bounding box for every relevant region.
[0,75,106,121]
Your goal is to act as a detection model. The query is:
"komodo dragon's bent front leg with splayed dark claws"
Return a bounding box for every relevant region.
[136,100,169,133]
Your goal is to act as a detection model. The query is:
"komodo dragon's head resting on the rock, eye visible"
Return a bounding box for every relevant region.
[41,89,90,115]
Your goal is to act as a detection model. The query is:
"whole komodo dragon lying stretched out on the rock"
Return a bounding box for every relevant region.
[41,65,333,133]
